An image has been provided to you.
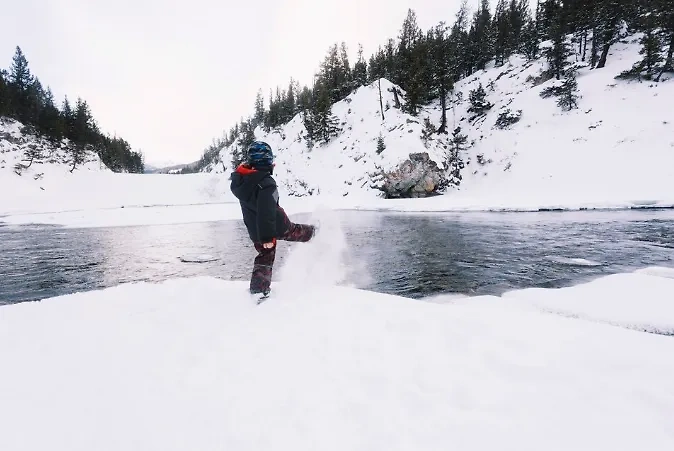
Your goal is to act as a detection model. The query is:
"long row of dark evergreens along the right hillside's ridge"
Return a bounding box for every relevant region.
[205,0,674,168]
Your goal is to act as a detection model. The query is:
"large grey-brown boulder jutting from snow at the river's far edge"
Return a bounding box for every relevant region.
[379,152,447,199]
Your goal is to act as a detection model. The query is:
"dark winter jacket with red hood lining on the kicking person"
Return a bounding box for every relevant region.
[231,165,291,243]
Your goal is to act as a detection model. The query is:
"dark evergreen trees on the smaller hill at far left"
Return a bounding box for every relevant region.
[0,47,144,173]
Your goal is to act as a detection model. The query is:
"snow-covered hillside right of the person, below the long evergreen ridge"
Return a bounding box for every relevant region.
[206,36,674,210]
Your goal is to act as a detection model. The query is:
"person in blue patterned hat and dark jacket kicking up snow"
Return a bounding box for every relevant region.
[231,141,316,296]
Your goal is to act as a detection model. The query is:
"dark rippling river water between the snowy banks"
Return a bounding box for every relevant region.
[0,211,674,304]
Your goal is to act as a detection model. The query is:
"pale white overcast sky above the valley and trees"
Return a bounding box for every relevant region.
[0,0,462,163]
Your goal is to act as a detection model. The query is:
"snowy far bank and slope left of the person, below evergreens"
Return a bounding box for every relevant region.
[0,118,233,218]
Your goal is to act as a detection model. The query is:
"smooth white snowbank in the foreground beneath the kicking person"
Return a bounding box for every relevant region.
[0,268,674,451]
